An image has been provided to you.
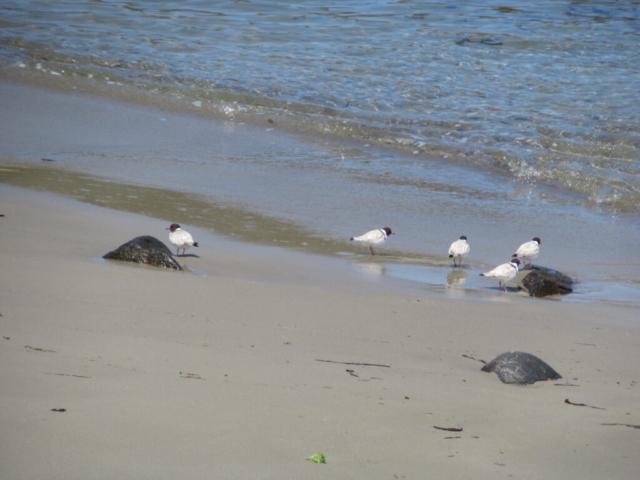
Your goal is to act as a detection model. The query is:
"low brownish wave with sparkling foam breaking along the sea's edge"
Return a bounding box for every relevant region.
[0,39,640,216]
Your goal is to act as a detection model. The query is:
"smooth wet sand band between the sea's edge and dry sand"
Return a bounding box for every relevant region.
[0,69,640,306]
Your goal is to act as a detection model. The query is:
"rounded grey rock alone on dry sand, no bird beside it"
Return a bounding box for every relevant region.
[482,352,562,385]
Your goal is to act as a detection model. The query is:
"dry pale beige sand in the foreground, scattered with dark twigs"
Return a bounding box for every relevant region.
[0,185,640,480]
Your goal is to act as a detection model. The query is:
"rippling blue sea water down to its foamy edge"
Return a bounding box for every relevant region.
[0,0,640,212]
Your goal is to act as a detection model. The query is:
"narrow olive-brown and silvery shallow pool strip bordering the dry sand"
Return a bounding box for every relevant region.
[0,160,640,308]
